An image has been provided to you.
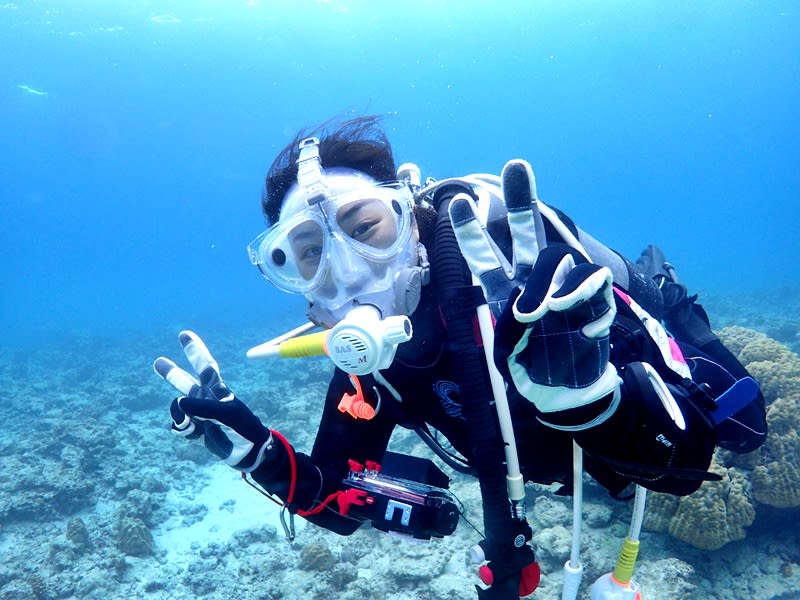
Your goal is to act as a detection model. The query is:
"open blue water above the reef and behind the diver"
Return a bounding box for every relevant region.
[0,0,800,345]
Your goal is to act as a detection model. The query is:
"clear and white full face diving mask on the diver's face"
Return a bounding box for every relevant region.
[248,138,423,327]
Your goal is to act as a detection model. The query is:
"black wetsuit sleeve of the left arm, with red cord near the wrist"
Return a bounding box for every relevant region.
[245,369,394,535]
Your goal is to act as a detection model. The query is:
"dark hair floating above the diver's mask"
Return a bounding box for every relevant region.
[261,115,397,225]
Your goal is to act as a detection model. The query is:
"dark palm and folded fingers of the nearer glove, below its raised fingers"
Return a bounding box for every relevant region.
[495,246,619,420]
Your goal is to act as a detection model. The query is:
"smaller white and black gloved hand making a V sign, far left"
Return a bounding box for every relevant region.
[153,331,272,473]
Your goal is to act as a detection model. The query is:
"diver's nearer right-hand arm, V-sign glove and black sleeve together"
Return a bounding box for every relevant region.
[450,160,718,494]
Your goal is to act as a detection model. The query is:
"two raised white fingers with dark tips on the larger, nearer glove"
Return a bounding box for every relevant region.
[449,160,544,318]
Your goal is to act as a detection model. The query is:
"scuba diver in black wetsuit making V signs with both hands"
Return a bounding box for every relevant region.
[154,116,767,598]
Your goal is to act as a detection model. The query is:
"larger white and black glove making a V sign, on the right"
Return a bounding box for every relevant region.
[450,160,618,421]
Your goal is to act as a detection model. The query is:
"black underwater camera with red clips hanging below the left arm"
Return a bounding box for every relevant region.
[338,452,460,540]
